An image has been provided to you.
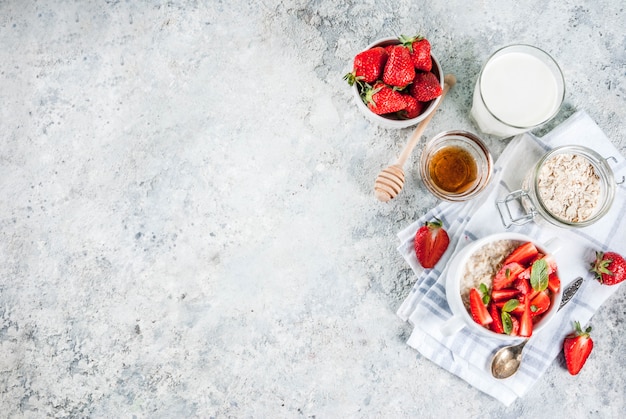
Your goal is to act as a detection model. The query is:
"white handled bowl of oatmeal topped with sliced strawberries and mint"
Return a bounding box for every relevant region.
[441,233,563,341]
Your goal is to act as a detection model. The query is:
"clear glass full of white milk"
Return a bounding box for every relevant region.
[470,45,565,138]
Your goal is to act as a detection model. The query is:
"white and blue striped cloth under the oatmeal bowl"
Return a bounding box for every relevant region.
[398,111,626,406]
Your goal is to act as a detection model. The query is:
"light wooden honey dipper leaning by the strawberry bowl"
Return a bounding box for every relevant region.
[374,74,456,202]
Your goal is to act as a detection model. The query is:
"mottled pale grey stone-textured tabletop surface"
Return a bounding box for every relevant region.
[0,0,626,418]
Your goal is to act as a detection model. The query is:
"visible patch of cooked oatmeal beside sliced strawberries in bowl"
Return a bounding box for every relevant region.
[460,240,522,308]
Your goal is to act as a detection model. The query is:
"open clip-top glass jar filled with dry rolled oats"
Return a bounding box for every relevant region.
[497,145,615,228]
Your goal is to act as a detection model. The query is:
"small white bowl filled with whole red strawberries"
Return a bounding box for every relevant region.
[344,35,444,128]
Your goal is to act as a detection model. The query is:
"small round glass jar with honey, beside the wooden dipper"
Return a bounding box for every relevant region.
[420,131,493,202]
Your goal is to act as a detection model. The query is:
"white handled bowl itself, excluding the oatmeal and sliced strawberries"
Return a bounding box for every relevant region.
[441,233,563,342]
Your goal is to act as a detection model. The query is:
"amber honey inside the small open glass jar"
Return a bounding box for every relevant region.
[428,146,478,193]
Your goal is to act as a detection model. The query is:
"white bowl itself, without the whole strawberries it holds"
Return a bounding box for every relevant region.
[352,38,444,129]
